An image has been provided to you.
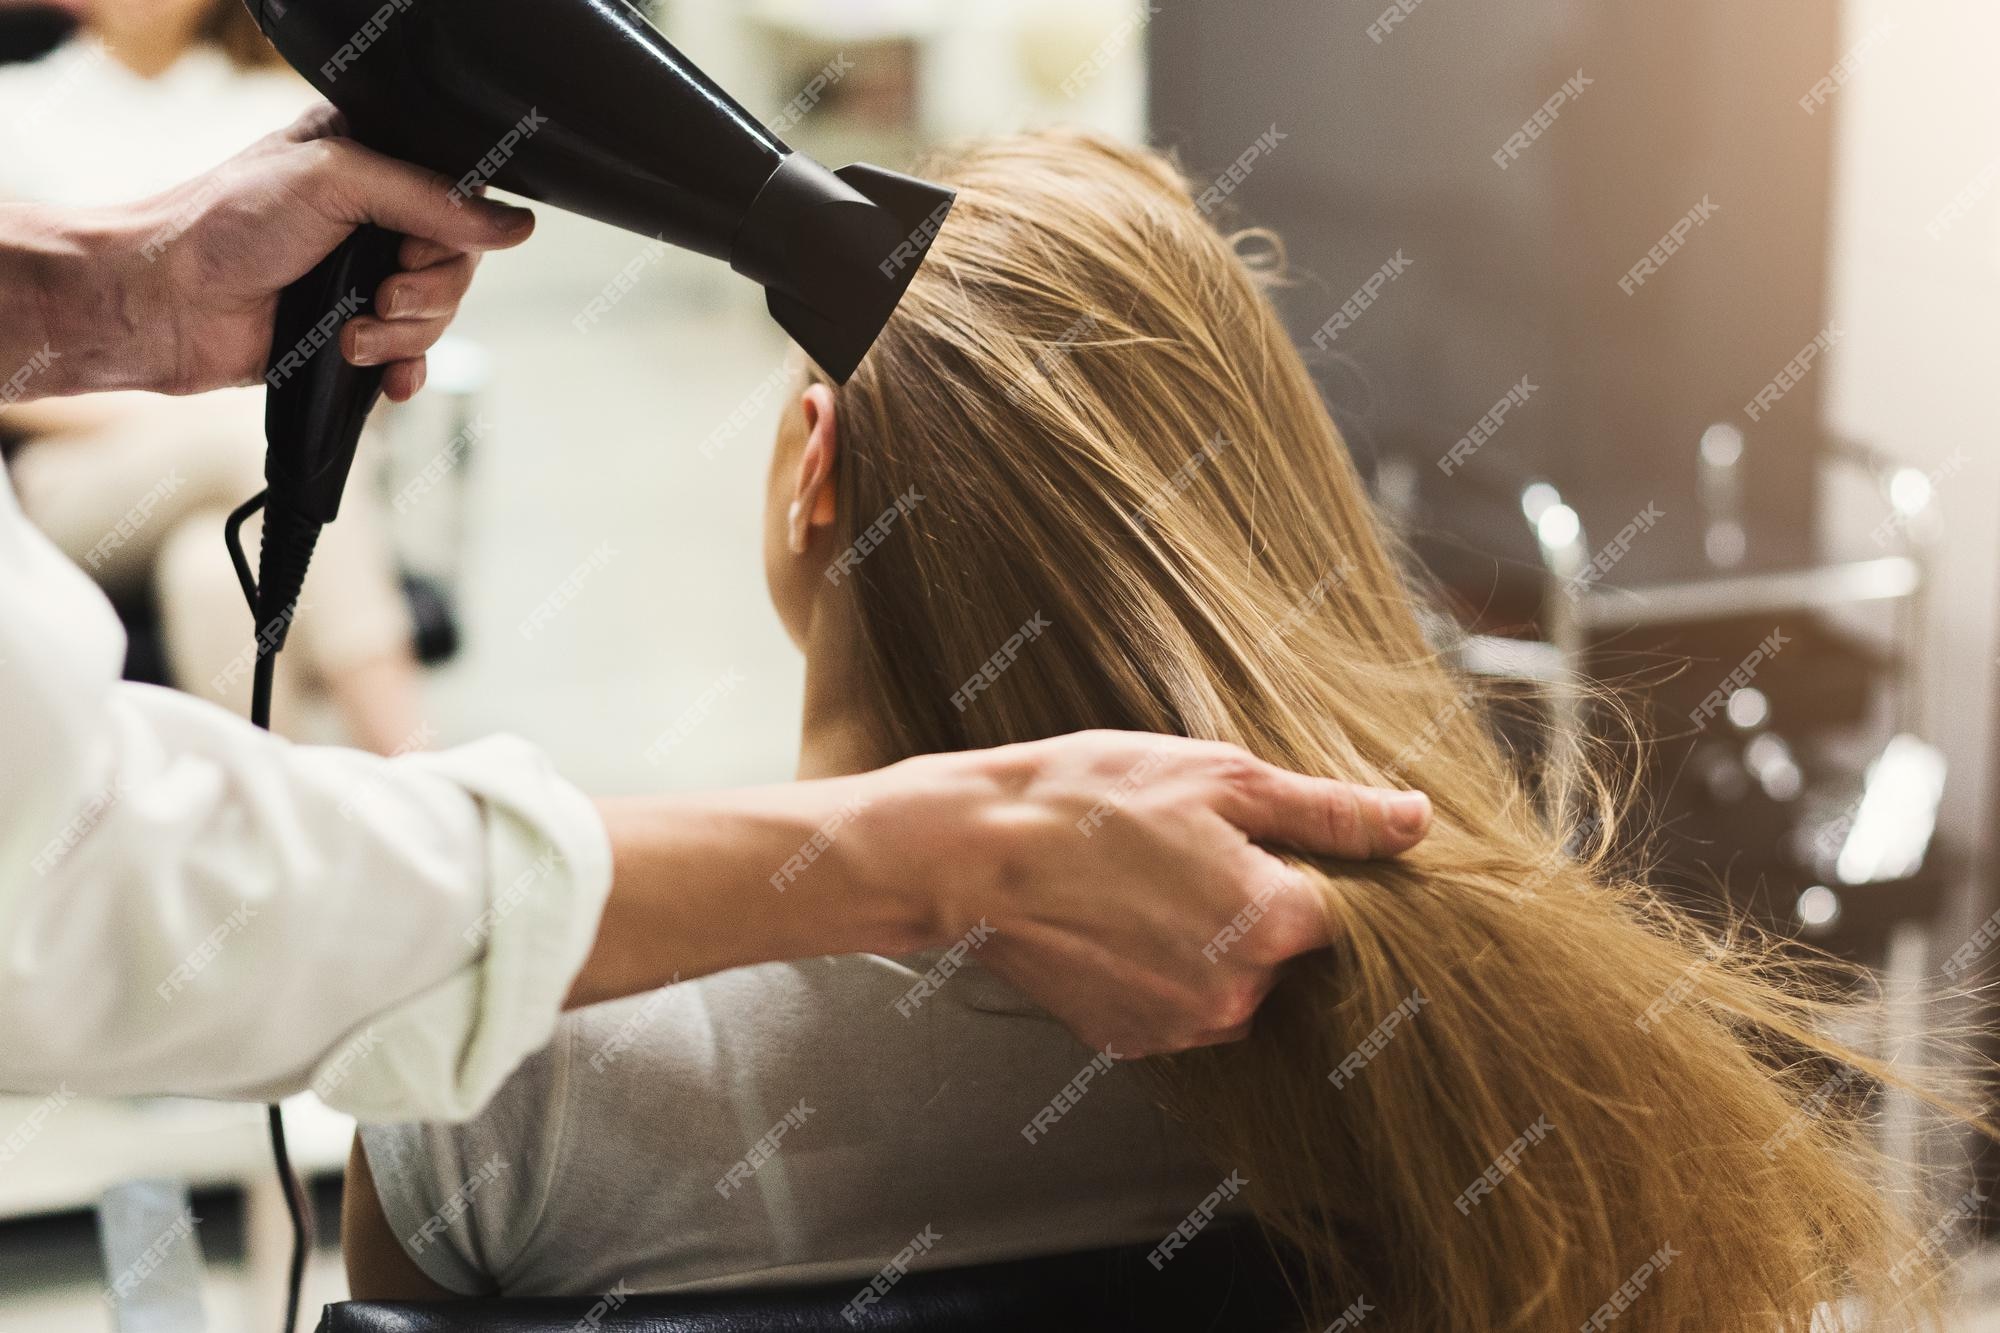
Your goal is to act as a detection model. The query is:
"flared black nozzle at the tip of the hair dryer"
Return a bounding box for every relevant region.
[730,152,958,384]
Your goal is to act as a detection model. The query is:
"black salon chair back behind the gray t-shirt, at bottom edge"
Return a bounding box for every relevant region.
[320,1225,1306,1333]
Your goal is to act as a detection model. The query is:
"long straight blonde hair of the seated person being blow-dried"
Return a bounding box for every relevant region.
[808,132,1968,1333]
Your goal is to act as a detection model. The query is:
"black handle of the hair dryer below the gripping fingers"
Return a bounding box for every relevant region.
[264,226,402,522]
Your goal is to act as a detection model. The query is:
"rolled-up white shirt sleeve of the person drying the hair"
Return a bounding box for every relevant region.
[0,474,610,1119]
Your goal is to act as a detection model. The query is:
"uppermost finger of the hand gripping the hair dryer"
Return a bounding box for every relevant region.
[308,138,534,252]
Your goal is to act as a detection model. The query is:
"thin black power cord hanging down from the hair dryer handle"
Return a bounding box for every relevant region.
[224,490,320,1333]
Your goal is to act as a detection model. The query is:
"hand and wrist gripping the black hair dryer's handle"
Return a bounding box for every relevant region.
[13,106,534,400]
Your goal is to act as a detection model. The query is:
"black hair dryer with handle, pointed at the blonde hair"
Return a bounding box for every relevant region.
[234,0,954,642]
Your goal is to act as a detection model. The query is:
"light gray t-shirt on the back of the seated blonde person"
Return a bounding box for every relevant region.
[362,940,1224,1295]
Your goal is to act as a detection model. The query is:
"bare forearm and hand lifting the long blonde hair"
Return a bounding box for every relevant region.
[568,731,1430,1059]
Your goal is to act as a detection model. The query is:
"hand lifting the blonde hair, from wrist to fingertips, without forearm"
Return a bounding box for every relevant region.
[884,731,1430,1059]
